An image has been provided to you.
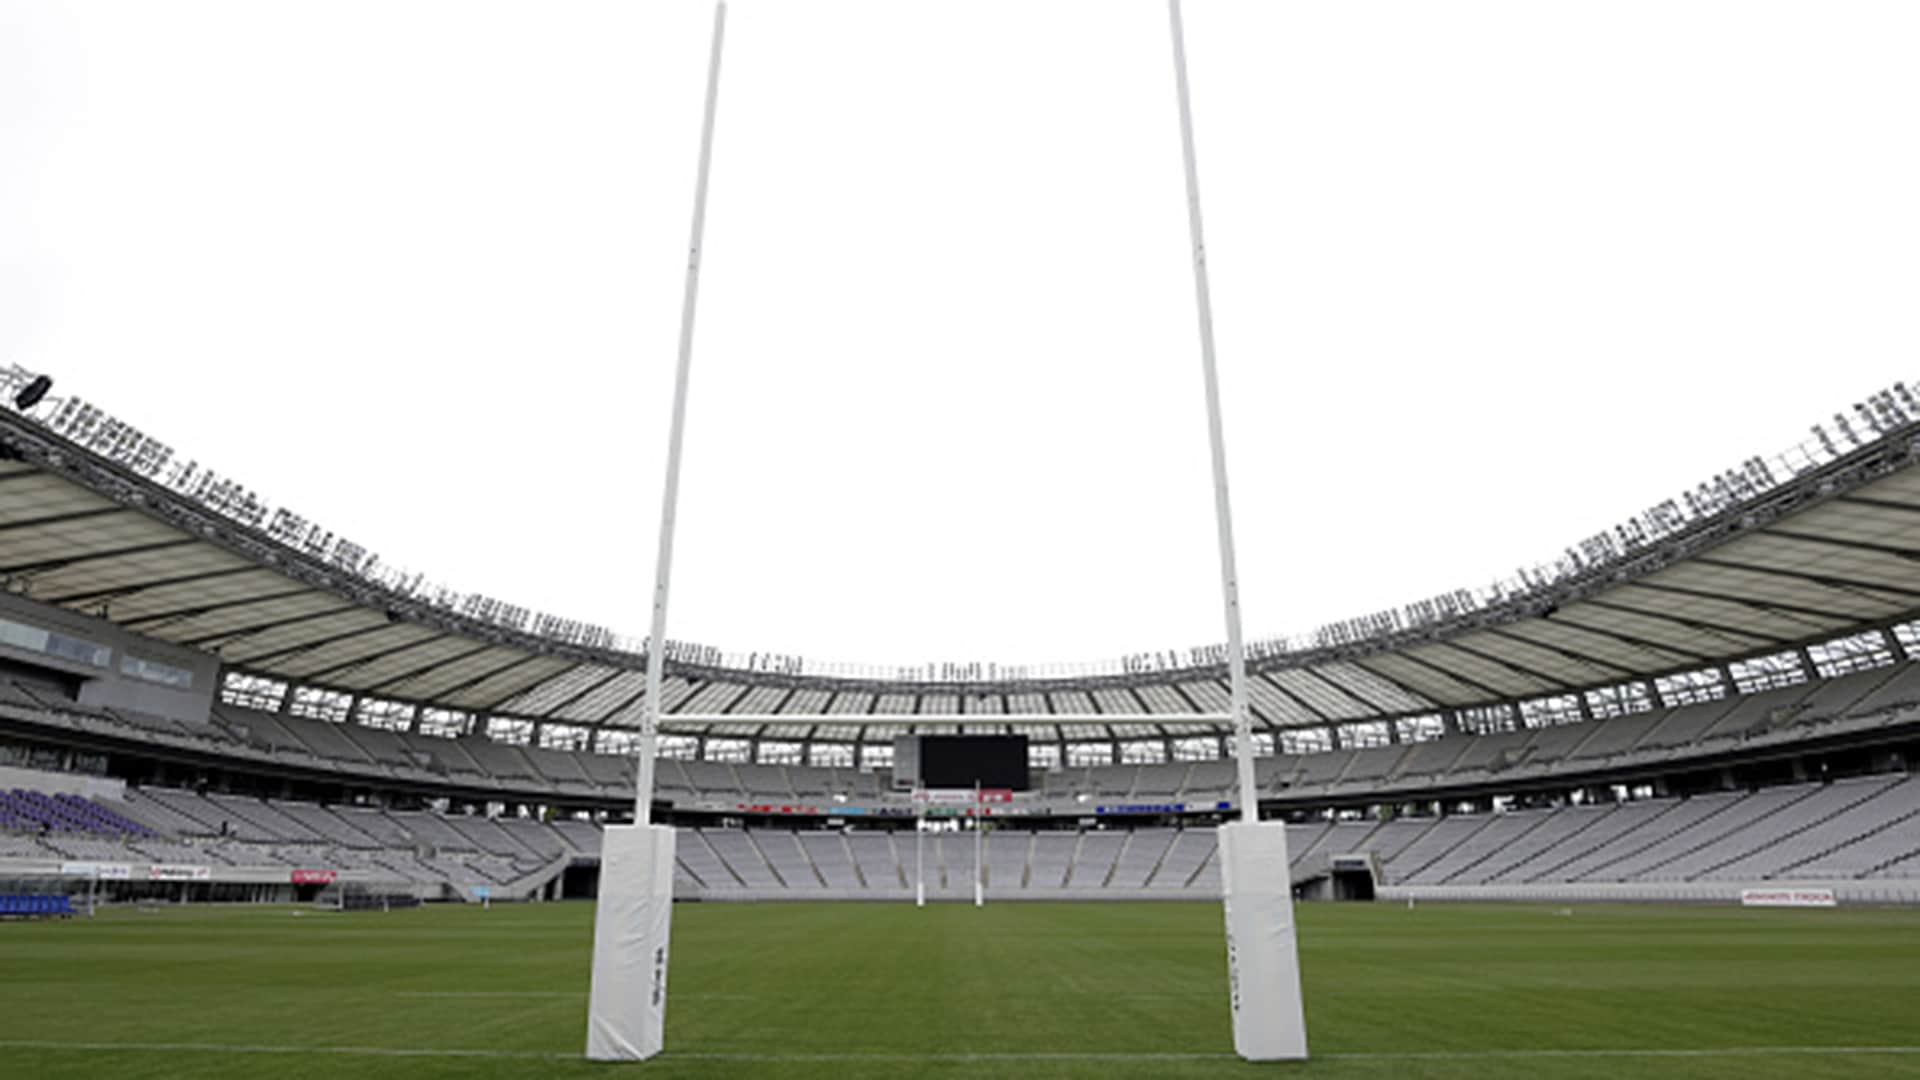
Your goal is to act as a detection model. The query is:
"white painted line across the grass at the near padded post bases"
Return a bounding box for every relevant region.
[0,1040,1920,1063]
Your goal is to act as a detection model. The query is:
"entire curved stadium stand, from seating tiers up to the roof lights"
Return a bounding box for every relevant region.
[0,371,1920,901]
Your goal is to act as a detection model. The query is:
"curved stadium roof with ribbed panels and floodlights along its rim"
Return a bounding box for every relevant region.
[0,369,1920,738]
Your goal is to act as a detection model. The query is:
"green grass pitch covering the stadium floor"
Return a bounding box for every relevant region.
[0,903,1920,1080]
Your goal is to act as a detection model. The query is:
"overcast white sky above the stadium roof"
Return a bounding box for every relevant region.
[0,0,1920,661]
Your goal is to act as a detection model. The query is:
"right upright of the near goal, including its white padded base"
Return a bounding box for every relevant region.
[1167,0,1308,1061]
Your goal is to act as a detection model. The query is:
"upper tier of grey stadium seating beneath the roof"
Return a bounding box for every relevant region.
[0,645,1920,817]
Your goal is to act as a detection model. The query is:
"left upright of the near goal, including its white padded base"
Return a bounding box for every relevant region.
[588,0,726,1061]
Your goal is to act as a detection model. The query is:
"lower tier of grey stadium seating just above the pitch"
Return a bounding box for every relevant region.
[0,774,1920,899]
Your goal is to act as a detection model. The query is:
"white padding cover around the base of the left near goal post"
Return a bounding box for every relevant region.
[588,824,674,1061]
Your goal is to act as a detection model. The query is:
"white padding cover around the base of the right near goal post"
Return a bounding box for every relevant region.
[1219,821,1308,1061]
